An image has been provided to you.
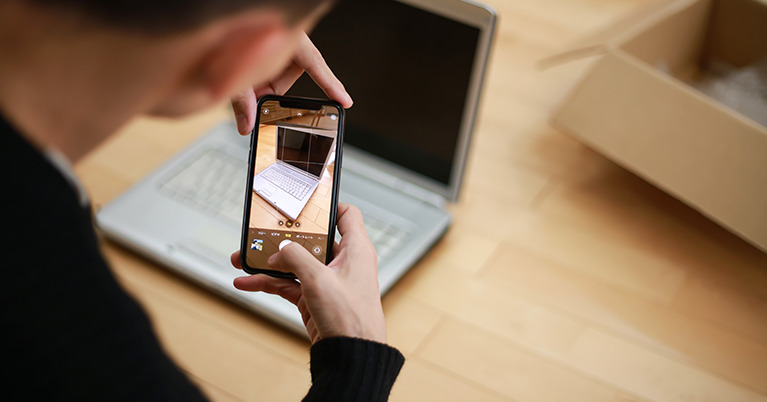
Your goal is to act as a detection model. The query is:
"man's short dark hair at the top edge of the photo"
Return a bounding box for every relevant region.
[25,0,328,34]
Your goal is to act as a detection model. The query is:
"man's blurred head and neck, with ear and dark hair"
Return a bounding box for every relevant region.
[0,0,332,160]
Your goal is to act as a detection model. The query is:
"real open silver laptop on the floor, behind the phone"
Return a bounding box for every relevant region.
[96,0,496,335]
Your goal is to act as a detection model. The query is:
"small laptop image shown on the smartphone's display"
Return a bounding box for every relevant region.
[253,124,335,221]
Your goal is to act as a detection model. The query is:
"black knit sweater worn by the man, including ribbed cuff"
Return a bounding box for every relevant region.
[0,114,404,401]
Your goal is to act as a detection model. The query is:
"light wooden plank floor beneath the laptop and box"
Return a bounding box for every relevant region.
[77,0,767,401]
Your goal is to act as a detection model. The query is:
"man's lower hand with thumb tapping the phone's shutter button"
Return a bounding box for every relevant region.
[232,204,386,344]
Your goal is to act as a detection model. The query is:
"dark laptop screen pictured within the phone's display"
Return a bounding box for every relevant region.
[277,126,335,178]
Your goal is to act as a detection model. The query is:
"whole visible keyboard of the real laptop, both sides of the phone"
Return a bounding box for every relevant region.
[159,148,409,262]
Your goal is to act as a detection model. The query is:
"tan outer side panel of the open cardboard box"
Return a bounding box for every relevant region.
[553,49,767,250]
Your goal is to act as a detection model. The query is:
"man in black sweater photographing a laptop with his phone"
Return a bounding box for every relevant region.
[0,0,403,401]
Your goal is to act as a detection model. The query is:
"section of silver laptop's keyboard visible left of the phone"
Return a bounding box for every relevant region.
[159,148,246,225]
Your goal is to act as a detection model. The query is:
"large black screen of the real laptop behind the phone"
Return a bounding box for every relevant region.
[289,0,480,185]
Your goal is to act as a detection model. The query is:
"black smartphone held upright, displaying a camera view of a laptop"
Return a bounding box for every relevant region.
[240,95,344,278]
